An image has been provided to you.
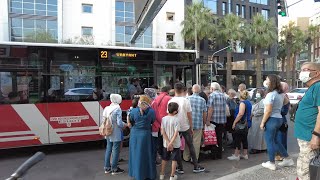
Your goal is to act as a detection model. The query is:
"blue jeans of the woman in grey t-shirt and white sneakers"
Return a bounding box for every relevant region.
[265,117,289,163]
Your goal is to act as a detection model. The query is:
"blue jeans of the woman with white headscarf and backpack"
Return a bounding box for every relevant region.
[104,138,121,170]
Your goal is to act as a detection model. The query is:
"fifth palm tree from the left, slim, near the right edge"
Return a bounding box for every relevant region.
[291,28,306,88]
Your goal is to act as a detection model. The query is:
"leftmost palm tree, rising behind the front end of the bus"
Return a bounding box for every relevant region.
[181,2,215,84]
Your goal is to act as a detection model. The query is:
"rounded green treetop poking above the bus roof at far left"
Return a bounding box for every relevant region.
[25,29,58,43]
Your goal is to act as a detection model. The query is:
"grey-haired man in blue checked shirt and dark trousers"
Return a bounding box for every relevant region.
[207,82,227,159]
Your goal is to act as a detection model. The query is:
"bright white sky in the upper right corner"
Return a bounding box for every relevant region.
[278,0,320,28]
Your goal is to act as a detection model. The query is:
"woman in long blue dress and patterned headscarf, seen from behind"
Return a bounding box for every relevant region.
[129,95,156,180]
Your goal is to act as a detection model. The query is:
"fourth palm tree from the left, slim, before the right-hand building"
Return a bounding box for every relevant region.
[280,21,297,87]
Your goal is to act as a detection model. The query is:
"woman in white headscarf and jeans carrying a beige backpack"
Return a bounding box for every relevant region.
[103,94,126,175]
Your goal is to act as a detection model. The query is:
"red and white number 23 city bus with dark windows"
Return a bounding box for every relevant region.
[0,42,195,149]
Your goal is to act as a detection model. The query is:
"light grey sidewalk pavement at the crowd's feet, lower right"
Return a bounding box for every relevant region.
[216,154,298,180]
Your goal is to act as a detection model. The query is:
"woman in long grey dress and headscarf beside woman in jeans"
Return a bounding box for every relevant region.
[248,89,267,154]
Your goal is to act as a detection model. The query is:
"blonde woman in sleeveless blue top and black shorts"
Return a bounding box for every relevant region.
[228,90,252,161]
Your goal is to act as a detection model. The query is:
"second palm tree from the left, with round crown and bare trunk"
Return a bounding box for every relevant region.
[217,14,243,89]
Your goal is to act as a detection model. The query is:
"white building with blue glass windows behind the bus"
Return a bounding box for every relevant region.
[0,0,185,49]
